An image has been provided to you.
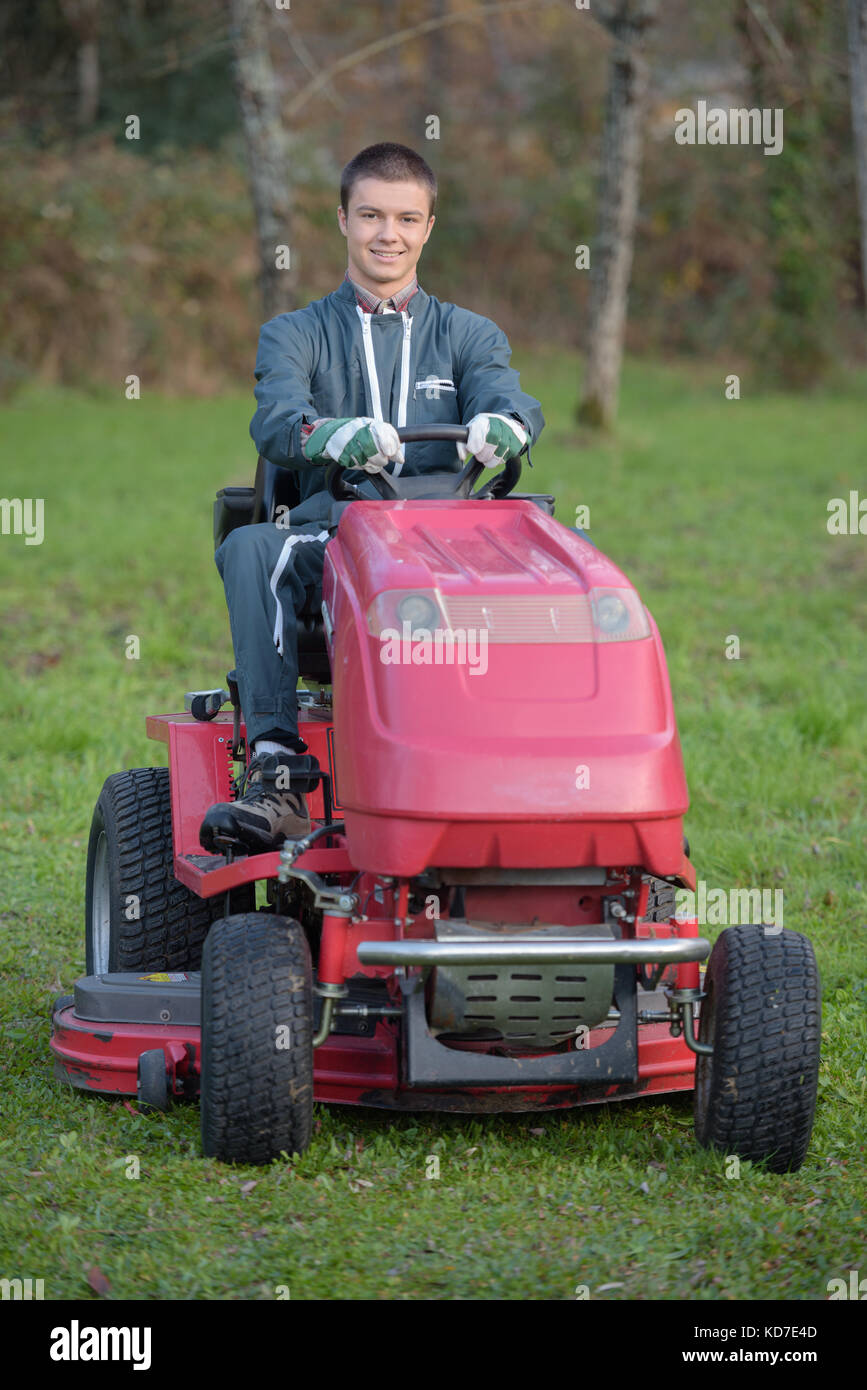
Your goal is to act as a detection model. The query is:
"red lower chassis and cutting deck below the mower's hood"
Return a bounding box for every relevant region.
[51,706,699,1111]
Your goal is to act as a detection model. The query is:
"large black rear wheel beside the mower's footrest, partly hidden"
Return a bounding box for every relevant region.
[85,767,256,974]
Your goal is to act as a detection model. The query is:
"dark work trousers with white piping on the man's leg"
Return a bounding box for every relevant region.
[214,521,328,751]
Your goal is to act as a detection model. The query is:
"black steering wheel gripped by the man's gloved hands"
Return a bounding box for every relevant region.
[325,424,521,502]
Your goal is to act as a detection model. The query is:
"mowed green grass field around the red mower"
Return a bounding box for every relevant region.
[0,353,867,1301]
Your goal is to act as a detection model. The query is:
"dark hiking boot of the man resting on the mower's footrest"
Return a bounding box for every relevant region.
[199,753,310,855]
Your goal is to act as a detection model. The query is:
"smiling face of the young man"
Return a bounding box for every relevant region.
[338,178,436,299]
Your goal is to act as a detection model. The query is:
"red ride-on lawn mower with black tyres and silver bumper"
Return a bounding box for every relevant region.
[51,425,820,1172]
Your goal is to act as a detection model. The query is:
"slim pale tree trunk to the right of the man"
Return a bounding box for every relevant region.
[578,0,656,428]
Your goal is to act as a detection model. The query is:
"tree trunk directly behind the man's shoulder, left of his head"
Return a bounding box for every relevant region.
[229,0,297,318]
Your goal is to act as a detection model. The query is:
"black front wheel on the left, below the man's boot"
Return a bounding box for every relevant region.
[201,912,313,1163]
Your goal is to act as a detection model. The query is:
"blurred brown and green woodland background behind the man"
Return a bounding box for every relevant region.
[0,0,864,396]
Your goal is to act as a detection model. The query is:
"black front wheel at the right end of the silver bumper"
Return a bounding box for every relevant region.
[695,926,821,1173]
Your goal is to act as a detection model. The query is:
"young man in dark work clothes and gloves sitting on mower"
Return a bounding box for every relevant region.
[200,145,545,852]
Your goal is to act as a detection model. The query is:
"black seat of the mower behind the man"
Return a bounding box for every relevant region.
[214,455,331,685]
